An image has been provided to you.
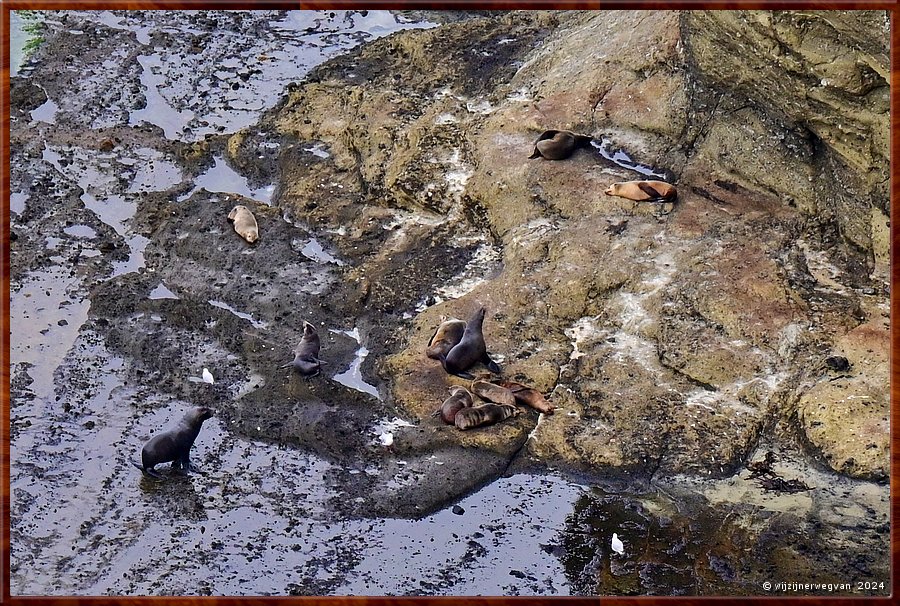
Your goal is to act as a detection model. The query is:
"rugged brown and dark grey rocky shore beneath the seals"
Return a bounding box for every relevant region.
[11,11,890,595]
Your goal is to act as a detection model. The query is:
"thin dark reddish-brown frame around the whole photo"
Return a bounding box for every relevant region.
[0,0,900,606]
